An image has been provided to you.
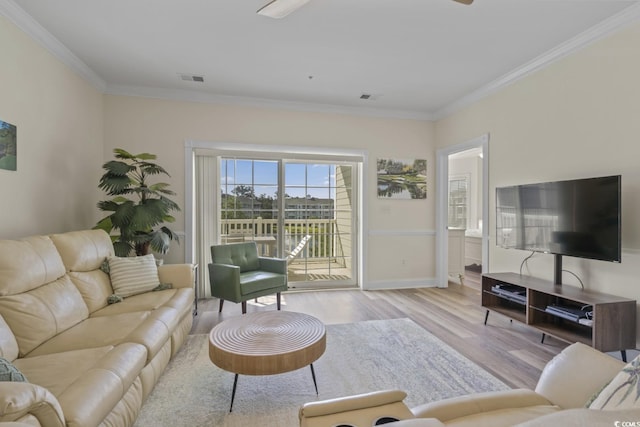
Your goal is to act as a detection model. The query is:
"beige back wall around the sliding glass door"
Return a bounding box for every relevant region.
[104,96,435,287]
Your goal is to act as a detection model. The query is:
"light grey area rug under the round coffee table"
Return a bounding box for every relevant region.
[135,319,509,427]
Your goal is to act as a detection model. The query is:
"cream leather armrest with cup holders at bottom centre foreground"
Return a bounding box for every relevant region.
[299,390,413,427]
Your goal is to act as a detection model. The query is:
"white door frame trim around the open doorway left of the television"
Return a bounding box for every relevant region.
[436,133,489,288]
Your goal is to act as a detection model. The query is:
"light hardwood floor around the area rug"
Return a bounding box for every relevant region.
[191,273,567,388]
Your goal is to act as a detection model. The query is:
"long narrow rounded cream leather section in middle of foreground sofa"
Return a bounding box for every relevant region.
[411,389,551,423]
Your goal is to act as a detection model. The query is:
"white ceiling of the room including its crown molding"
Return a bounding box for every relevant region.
[0,0,640,119]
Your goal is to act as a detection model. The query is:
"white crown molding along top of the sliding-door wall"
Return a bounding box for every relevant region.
[105,85,433,121]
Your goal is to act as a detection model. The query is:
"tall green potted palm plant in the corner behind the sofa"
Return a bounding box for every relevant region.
[94,148,180,256]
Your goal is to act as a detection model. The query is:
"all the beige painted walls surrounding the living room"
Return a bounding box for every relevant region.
[7,5,640,306]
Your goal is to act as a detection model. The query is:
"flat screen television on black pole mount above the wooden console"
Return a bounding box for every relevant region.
[496,175,622,284]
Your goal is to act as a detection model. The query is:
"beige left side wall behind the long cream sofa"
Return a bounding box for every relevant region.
[0,16,103,238]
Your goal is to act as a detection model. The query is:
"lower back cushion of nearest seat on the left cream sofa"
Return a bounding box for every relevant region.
[0,276,89,357]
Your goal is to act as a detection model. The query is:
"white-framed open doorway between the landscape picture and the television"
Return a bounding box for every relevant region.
[436,134,489,287]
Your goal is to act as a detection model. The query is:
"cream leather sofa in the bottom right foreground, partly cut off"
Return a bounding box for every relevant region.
[300,343,640,427]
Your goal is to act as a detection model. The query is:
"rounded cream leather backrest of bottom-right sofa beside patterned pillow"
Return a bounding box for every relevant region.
[535,343,625,409]
